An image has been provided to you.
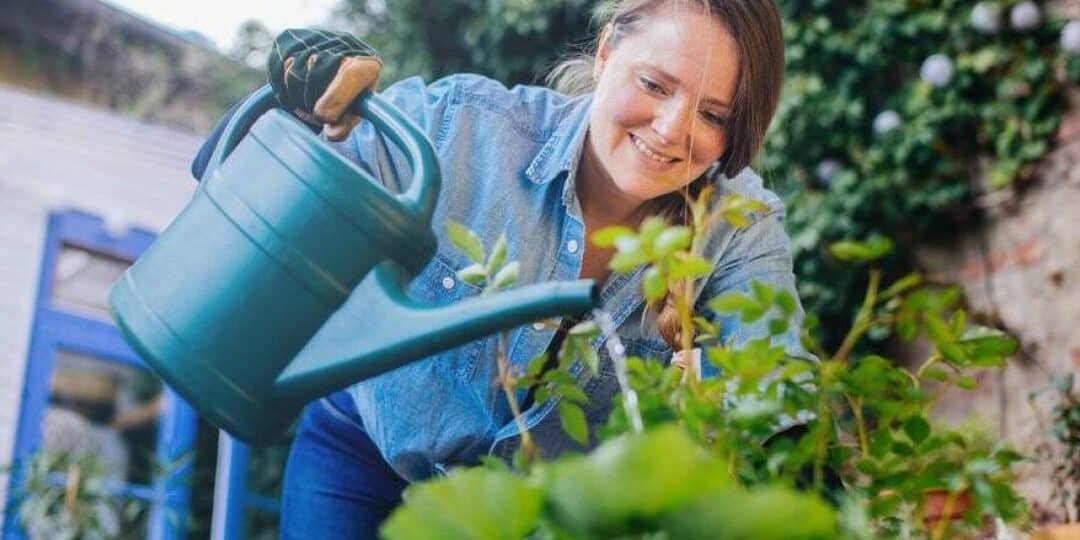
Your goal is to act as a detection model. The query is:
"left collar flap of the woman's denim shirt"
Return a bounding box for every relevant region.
[525,94,593,184]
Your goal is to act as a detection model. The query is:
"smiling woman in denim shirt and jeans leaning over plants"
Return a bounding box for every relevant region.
[194,0,801,538]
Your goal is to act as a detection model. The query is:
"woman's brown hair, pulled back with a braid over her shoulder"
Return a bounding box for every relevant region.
[546,0,784,350]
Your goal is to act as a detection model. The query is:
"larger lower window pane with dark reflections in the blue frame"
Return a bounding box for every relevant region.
[43,351,165,485]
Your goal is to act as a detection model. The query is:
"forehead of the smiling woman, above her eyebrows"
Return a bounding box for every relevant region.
[612,5,739,103]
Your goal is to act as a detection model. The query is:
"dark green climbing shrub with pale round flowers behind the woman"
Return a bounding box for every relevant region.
[760,0,1080,343]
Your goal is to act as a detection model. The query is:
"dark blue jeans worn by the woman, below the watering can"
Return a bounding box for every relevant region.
[281,391,407,540]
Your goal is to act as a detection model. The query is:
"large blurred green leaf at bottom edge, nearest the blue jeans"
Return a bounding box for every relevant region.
[379,468,542,540]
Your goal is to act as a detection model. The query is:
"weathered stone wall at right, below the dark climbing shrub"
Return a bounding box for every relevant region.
[908,84,1080,509]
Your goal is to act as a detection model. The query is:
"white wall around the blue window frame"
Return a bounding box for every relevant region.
[0,86,201,519]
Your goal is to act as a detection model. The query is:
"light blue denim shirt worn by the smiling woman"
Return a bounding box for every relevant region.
[313,75,802,481]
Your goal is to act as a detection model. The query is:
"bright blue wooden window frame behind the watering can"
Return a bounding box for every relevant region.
[3,211,199,540]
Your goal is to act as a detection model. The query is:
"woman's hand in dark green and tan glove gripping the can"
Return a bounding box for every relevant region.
[267,29,382,140]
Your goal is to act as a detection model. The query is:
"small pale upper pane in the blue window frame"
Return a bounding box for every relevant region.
[52,245,131,320]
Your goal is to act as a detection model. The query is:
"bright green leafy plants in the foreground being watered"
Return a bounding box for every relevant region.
[383,191,1026,538]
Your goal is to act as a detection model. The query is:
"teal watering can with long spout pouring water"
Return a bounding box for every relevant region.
[109,87,597,445]
